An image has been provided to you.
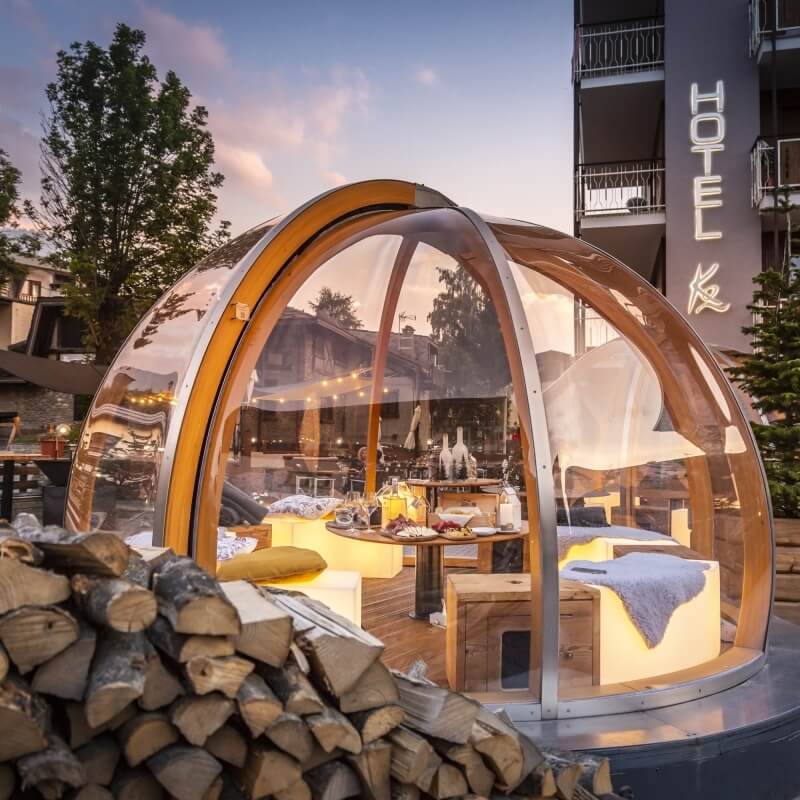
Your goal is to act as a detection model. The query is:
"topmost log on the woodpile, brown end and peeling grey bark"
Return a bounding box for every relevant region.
[19,525,130,578]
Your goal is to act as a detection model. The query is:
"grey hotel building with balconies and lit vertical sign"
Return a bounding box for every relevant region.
[573,0,800,351]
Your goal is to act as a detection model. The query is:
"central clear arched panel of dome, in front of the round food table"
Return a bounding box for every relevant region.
[203,210,538,701]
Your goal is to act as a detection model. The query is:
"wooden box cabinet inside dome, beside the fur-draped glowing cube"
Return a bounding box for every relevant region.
[445,573,600,693]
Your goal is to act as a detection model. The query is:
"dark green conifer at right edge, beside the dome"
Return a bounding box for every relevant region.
[729,192,800,517]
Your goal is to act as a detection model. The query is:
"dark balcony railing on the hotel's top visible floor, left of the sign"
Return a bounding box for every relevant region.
[572,17,664,81]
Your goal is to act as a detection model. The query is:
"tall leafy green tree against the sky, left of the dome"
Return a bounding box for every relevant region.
[32,24,229,363]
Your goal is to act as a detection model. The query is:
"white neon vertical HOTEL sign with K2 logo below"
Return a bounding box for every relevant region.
[688,81,731,316]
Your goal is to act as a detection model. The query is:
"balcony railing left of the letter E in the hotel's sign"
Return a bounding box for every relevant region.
[575,159,666,219]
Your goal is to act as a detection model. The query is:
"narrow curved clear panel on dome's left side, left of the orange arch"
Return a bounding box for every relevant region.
[66,222,272,539]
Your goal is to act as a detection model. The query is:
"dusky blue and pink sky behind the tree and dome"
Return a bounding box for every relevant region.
[0,0,572,234]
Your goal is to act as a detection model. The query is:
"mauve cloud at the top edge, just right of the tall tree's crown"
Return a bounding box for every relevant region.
[139,4,231,73]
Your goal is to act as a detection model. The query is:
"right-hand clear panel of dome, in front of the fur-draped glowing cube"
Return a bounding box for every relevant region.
[492,216,769,698]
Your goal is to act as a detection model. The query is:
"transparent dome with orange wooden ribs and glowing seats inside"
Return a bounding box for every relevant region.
[68,181,773,719]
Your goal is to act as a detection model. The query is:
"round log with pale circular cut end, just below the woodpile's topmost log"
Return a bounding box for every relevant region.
[72,576,157,633]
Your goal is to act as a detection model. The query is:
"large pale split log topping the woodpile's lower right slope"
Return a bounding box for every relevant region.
[394,672,480,744]
